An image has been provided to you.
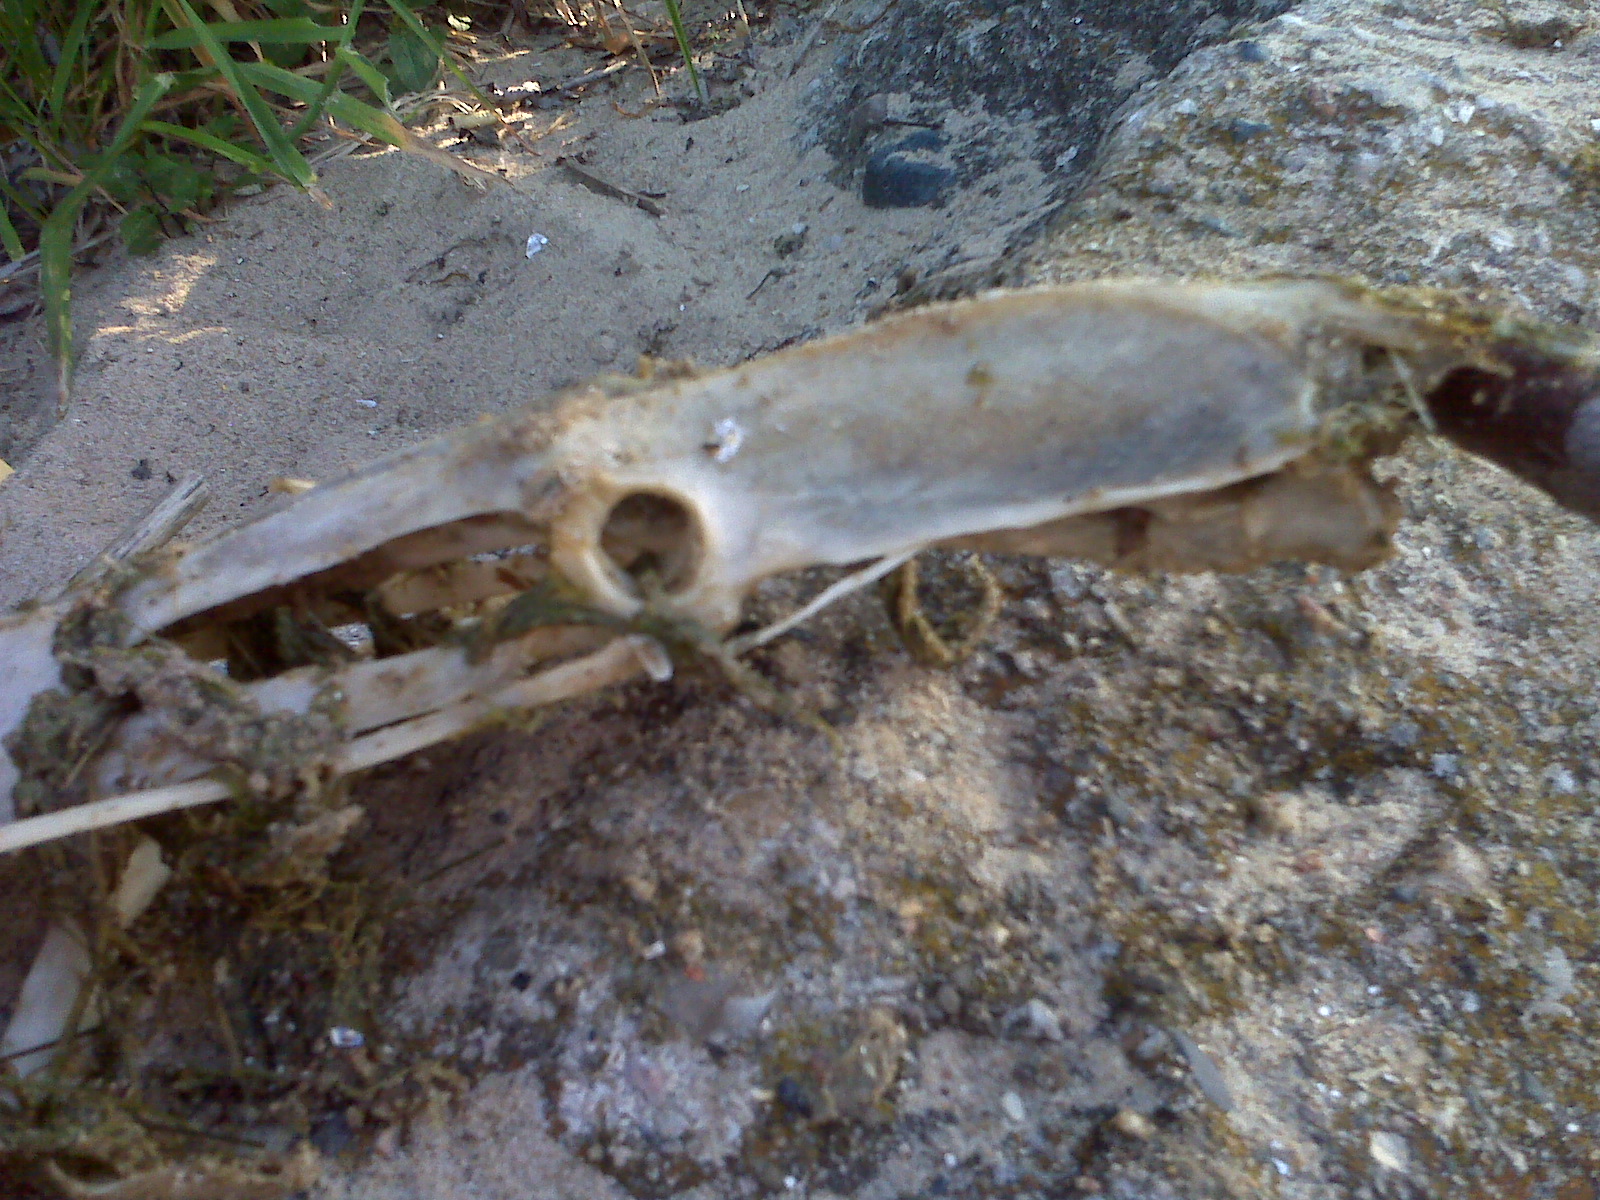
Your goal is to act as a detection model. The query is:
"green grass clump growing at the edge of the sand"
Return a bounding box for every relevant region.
[0,0,521,402]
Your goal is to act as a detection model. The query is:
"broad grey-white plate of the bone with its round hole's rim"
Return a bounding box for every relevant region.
[552,282,1376,627]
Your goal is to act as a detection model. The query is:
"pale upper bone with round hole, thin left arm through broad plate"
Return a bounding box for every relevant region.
[122,280,1416,632]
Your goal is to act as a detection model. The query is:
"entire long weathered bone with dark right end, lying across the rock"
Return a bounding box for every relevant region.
[0,280,1600,851]
